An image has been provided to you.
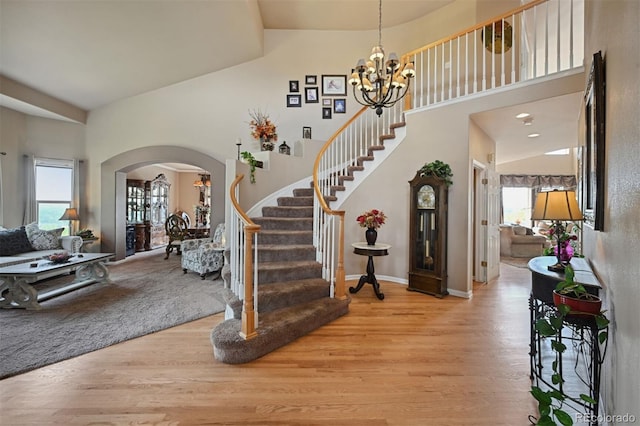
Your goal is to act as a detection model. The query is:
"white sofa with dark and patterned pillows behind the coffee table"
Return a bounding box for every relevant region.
[0,223,82,268]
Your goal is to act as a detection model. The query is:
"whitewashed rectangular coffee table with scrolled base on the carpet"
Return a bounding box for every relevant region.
[0,253,114,310]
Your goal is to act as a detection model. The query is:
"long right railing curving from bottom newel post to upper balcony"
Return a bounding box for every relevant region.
[313,0,584,297]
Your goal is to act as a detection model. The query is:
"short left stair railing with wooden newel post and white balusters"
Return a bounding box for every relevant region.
[229,174,260,339]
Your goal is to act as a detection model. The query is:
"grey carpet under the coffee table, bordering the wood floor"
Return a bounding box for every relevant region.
[0,250,225,379]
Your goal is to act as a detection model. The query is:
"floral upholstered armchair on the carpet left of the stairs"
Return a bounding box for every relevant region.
[180,223,225,280]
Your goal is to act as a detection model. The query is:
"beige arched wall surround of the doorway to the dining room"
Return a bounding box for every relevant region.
[100,146,225,260]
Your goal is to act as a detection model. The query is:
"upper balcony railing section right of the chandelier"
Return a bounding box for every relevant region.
[402,0,584,110]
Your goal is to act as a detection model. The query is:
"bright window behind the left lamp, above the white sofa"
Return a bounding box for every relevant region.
[35,158,74,235]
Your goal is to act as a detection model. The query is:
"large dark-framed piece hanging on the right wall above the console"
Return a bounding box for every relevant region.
[579,52,605,231]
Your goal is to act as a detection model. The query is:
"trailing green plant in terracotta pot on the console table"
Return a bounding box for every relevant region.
[530,265,609,425]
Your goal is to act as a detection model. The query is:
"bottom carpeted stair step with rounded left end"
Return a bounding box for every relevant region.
[211,297,351,364]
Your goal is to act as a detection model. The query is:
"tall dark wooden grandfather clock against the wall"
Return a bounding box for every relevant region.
[407,171,449,297]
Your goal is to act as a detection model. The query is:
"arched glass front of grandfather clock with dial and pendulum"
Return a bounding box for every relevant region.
[415,185,437,271]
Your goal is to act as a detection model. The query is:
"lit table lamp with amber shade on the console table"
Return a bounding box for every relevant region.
[531,189,584,272]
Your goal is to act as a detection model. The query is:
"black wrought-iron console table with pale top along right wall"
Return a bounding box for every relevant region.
[528,256,606,425]
